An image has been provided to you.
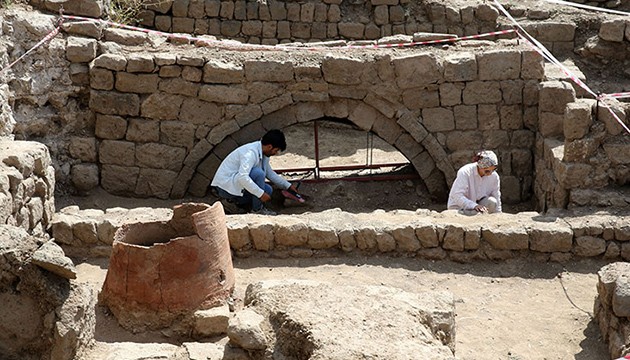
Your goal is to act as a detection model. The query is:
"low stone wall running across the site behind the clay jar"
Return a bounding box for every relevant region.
[52,204,630,262]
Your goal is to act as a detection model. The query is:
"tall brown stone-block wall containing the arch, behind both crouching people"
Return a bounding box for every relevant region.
[68,38,543,202]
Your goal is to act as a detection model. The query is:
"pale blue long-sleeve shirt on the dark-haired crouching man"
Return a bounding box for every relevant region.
[212,141,291,197]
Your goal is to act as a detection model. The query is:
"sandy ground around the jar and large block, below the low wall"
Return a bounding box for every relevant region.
[78,257,609,360]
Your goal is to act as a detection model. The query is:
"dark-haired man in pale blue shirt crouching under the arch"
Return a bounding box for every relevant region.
[211,130,297,215]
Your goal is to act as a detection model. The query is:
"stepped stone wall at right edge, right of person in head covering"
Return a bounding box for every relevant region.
[534,81,630,210]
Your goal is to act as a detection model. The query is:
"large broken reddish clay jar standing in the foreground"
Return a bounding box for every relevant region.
[100,202,234,332]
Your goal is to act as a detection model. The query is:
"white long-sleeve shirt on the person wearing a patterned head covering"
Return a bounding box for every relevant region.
[448,162,502,212]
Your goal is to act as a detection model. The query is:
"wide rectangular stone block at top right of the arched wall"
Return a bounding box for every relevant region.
[477,50,521,81]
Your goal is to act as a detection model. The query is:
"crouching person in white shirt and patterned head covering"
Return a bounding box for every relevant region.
[448,151,501,215]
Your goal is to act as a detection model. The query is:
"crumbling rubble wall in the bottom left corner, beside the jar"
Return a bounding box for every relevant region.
[0,225,96,360]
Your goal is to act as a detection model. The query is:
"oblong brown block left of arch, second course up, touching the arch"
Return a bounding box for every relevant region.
[136,143,186,171]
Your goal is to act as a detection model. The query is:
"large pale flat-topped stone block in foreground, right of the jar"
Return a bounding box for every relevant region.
[245,280,455,360]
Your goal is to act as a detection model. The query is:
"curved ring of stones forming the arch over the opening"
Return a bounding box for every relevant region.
[171,99,455,198]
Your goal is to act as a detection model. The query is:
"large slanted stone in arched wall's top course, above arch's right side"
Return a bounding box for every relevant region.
[392,54,444,89]
